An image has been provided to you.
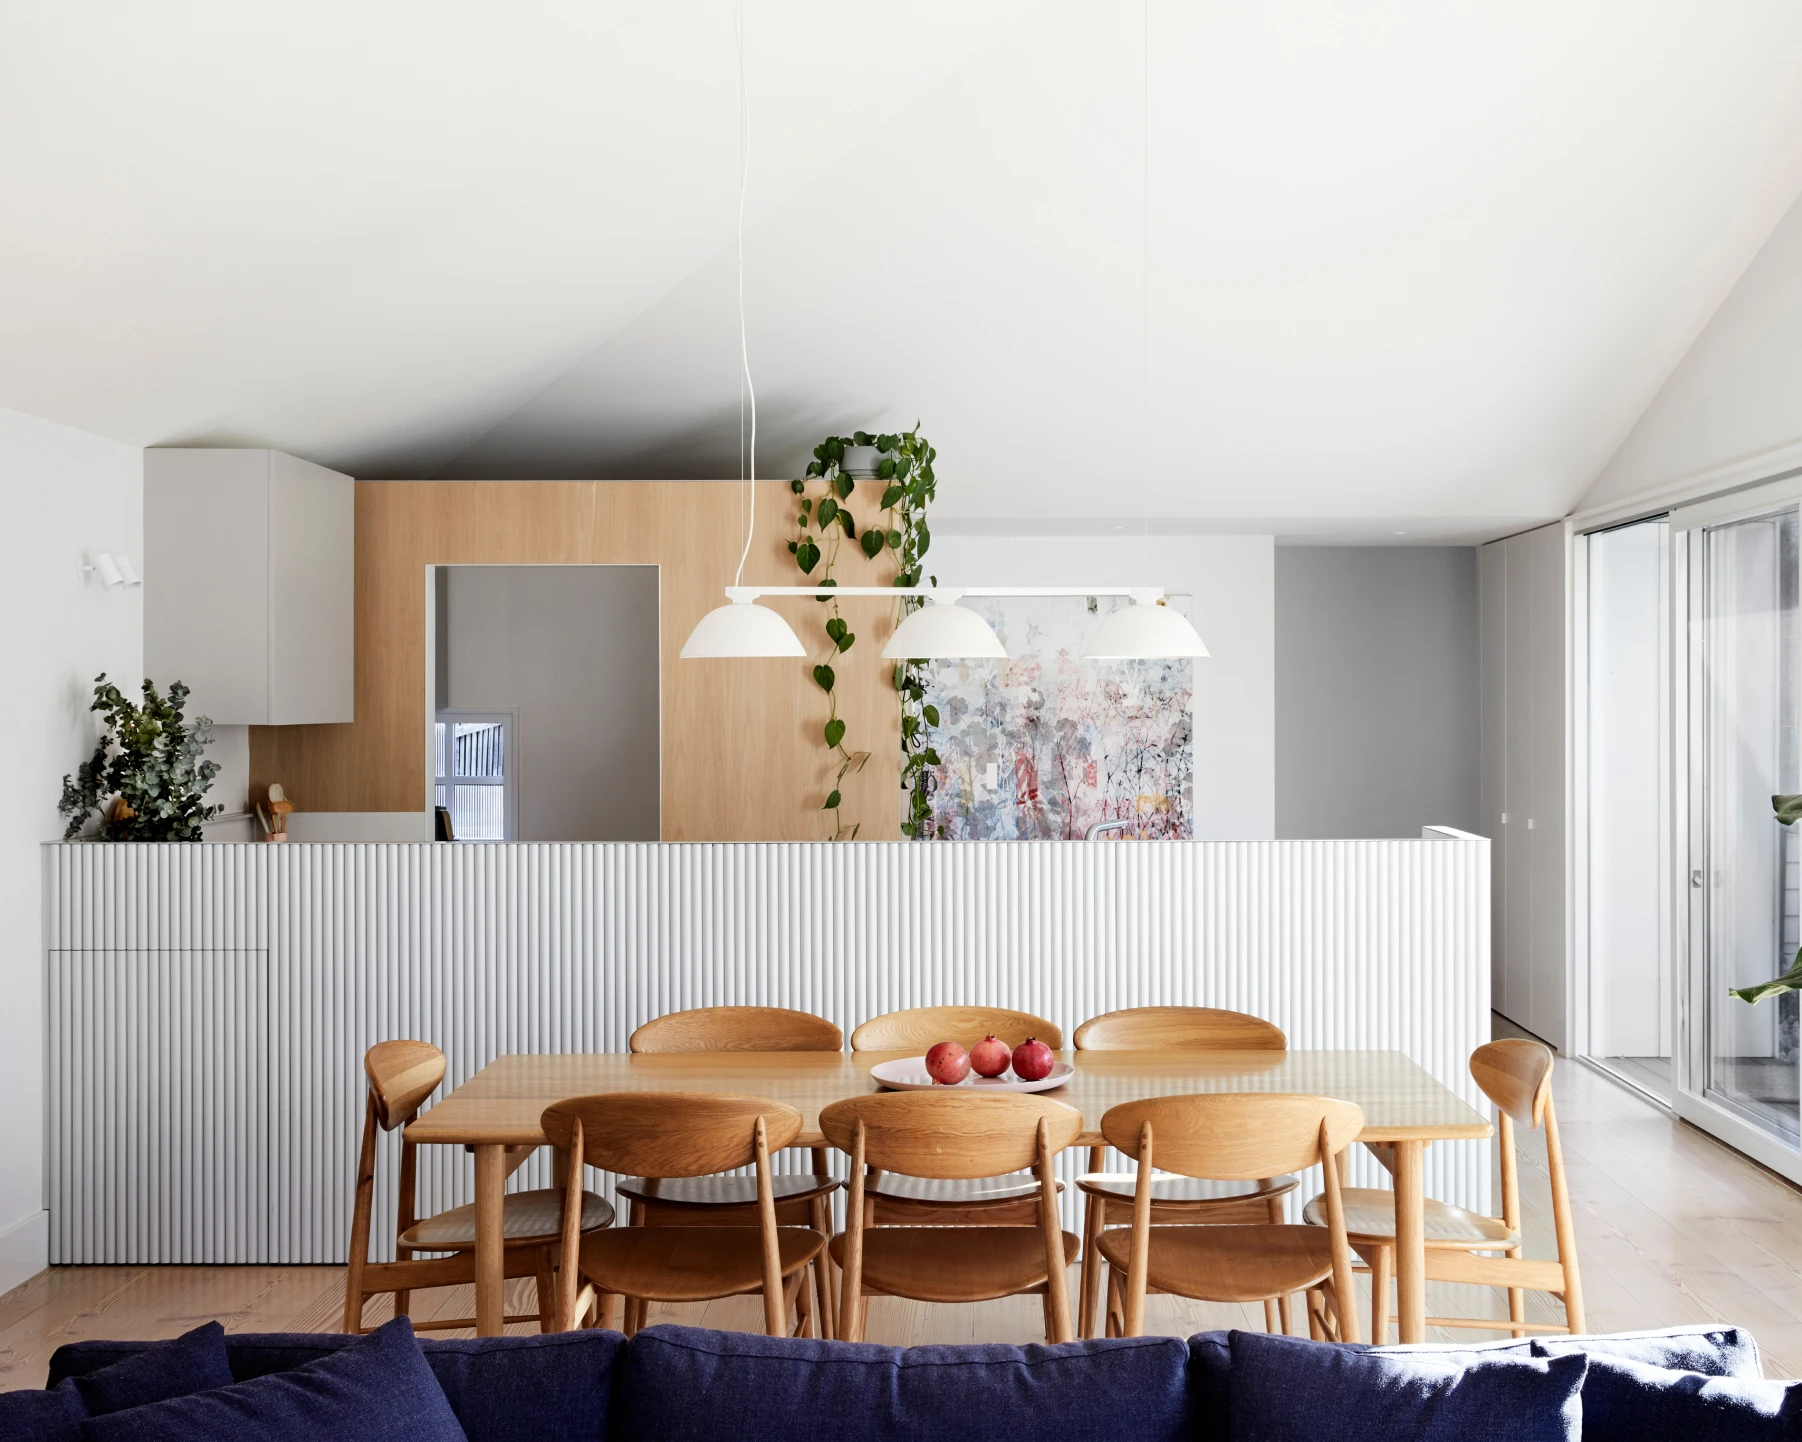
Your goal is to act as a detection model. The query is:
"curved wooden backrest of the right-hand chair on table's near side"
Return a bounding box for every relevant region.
[1101,1092,1364,1181]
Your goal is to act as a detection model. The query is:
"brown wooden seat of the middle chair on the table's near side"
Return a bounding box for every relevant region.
[833,1228,1081,1301]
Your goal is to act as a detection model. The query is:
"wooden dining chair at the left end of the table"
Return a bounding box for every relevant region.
[344,1042,613,1332]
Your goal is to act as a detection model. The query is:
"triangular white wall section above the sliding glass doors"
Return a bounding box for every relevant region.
[1579,188,1802,510]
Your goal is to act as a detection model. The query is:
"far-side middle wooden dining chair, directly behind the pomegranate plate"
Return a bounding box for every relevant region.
[851,1006,1063,1226]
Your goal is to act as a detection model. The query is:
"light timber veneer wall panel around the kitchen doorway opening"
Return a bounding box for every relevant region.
[250,481,901,842]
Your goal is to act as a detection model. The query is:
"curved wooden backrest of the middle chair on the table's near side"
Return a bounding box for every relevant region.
[820,1095,1083,1181]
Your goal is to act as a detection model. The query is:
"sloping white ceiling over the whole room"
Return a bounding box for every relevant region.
[0,0,1802,539]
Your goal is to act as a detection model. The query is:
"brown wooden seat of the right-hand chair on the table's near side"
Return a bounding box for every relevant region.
[1099,1224,1333,1301]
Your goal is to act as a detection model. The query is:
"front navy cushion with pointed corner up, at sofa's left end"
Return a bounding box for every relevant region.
[81,1318,465,1442]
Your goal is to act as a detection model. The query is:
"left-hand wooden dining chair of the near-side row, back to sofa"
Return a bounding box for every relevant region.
[541,1092,825,1337]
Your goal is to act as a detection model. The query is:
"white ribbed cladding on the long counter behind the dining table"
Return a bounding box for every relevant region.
[45,840,1490,1264]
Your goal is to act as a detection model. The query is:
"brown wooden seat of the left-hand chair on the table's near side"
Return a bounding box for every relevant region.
[580,1228,825,1301]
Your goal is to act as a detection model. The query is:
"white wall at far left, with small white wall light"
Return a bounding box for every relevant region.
[0,409,144,1292]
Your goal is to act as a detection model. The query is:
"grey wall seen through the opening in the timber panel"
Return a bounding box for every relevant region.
[436,566,661,842]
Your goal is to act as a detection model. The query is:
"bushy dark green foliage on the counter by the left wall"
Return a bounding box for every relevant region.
[56,671,225,842]
